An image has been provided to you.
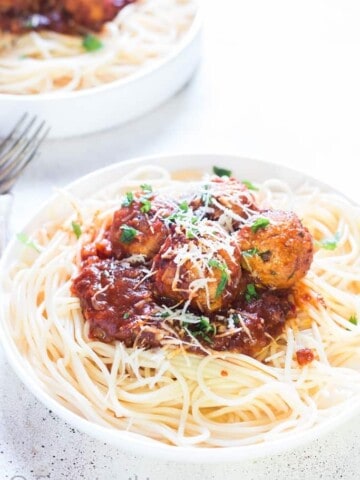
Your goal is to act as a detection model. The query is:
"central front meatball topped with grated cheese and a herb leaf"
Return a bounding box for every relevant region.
[153,220,241,313]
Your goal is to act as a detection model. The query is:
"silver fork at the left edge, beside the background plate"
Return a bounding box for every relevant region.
[0,113,50,255]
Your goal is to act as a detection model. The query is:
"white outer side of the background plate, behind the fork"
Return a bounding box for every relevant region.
[0,8,202,138]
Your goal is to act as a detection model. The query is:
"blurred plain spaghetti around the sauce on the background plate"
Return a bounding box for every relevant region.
[0,0,196,95]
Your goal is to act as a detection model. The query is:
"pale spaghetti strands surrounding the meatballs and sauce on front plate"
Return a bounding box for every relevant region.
[3,167,360,447]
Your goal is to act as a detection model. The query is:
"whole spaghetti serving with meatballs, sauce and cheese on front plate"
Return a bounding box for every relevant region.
[4,167,360,447]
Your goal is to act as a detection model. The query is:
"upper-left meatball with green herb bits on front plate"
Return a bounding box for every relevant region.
[109,193,172,260]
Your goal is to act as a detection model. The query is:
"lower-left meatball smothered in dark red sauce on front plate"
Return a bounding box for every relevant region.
[71,257,160,347]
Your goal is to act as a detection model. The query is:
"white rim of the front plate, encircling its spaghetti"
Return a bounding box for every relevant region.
[0,155,360,463]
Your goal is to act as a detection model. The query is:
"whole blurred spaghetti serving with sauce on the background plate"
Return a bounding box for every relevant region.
[0,0,196,95]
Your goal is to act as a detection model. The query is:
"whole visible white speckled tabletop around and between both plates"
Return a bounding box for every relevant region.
[0,0,360,480]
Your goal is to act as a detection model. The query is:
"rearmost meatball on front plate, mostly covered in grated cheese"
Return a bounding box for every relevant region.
[190,177,258,231]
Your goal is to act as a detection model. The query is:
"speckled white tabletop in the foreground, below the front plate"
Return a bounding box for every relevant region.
[0,353,360,480]
